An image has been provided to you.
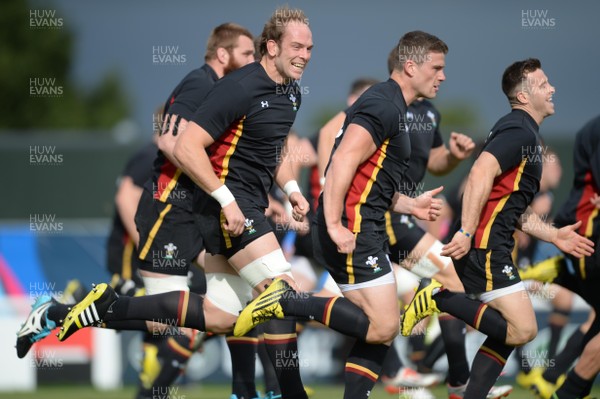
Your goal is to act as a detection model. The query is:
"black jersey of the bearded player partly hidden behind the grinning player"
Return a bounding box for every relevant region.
[144,64,219,211]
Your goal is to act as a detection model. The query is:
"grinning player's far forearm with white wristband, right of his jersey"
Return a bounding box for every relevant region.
[275,137,310,220]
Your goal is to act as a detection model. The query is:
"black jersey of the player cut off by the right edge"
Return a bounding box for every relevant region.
[554,116,600,238]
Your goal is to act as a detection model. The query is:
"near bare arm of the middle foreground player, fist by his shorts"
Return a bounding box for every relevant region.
[323,123,377,253]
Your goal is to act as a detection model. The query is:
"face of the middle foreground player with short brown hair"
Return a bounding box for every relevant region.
[410,52,446,98]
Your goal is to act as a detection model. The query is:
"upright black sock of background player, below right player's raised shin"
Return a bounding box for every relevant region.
[439,315,470,387]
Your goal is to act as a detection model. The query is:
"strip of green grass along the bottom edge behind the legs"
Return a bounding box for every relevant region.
[0,384,600,399]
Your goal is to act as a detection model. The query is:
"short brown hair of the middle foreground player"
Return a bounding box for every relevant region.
[388,30,448,73]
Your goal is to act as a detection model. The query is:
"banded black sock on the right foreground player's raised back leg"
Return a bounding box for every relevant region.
[433,290,507,342]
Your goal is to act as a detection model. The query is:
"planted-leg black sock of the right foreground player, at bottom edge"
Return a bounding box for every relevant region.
[464,337,514,399]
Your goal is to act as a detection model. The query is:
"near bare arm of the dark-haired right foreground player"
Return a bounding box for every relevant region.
[441,151,502,259]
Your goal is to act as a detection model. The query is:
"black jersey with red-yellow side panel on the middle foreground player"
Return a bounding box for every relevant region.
[319,79,410,233]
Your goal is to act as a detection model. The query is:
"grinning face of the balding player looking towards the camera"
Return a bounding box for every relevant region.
[267,21,313,81]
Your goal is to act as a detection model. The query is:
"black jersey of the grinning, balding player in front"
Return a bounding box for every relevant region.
[193,62,301,208]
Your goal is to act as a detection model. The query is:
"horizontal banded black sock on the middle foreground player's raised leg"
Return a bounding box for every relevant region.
[280,291,370,341]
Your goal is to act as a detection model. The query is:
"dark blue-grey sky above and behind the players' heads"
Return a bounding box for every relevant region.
[50,0,600,141]
